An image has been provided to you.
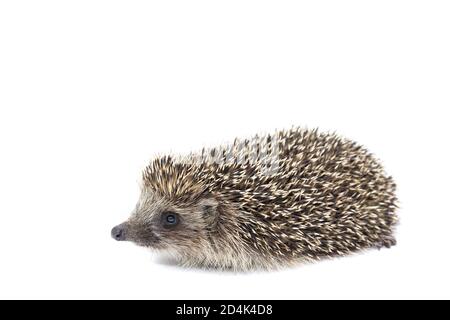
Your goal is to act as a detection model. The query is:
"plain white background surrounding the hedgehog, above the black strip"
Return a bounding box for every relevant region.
[0,0,450,299]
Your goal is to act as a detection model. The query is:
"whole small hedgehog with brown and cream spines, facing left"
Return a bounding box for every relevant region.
[111,128,397,271]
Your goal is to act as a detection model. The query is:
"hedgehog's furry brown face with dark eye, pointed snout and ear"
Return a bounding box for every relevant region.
[111,190,217,252]
